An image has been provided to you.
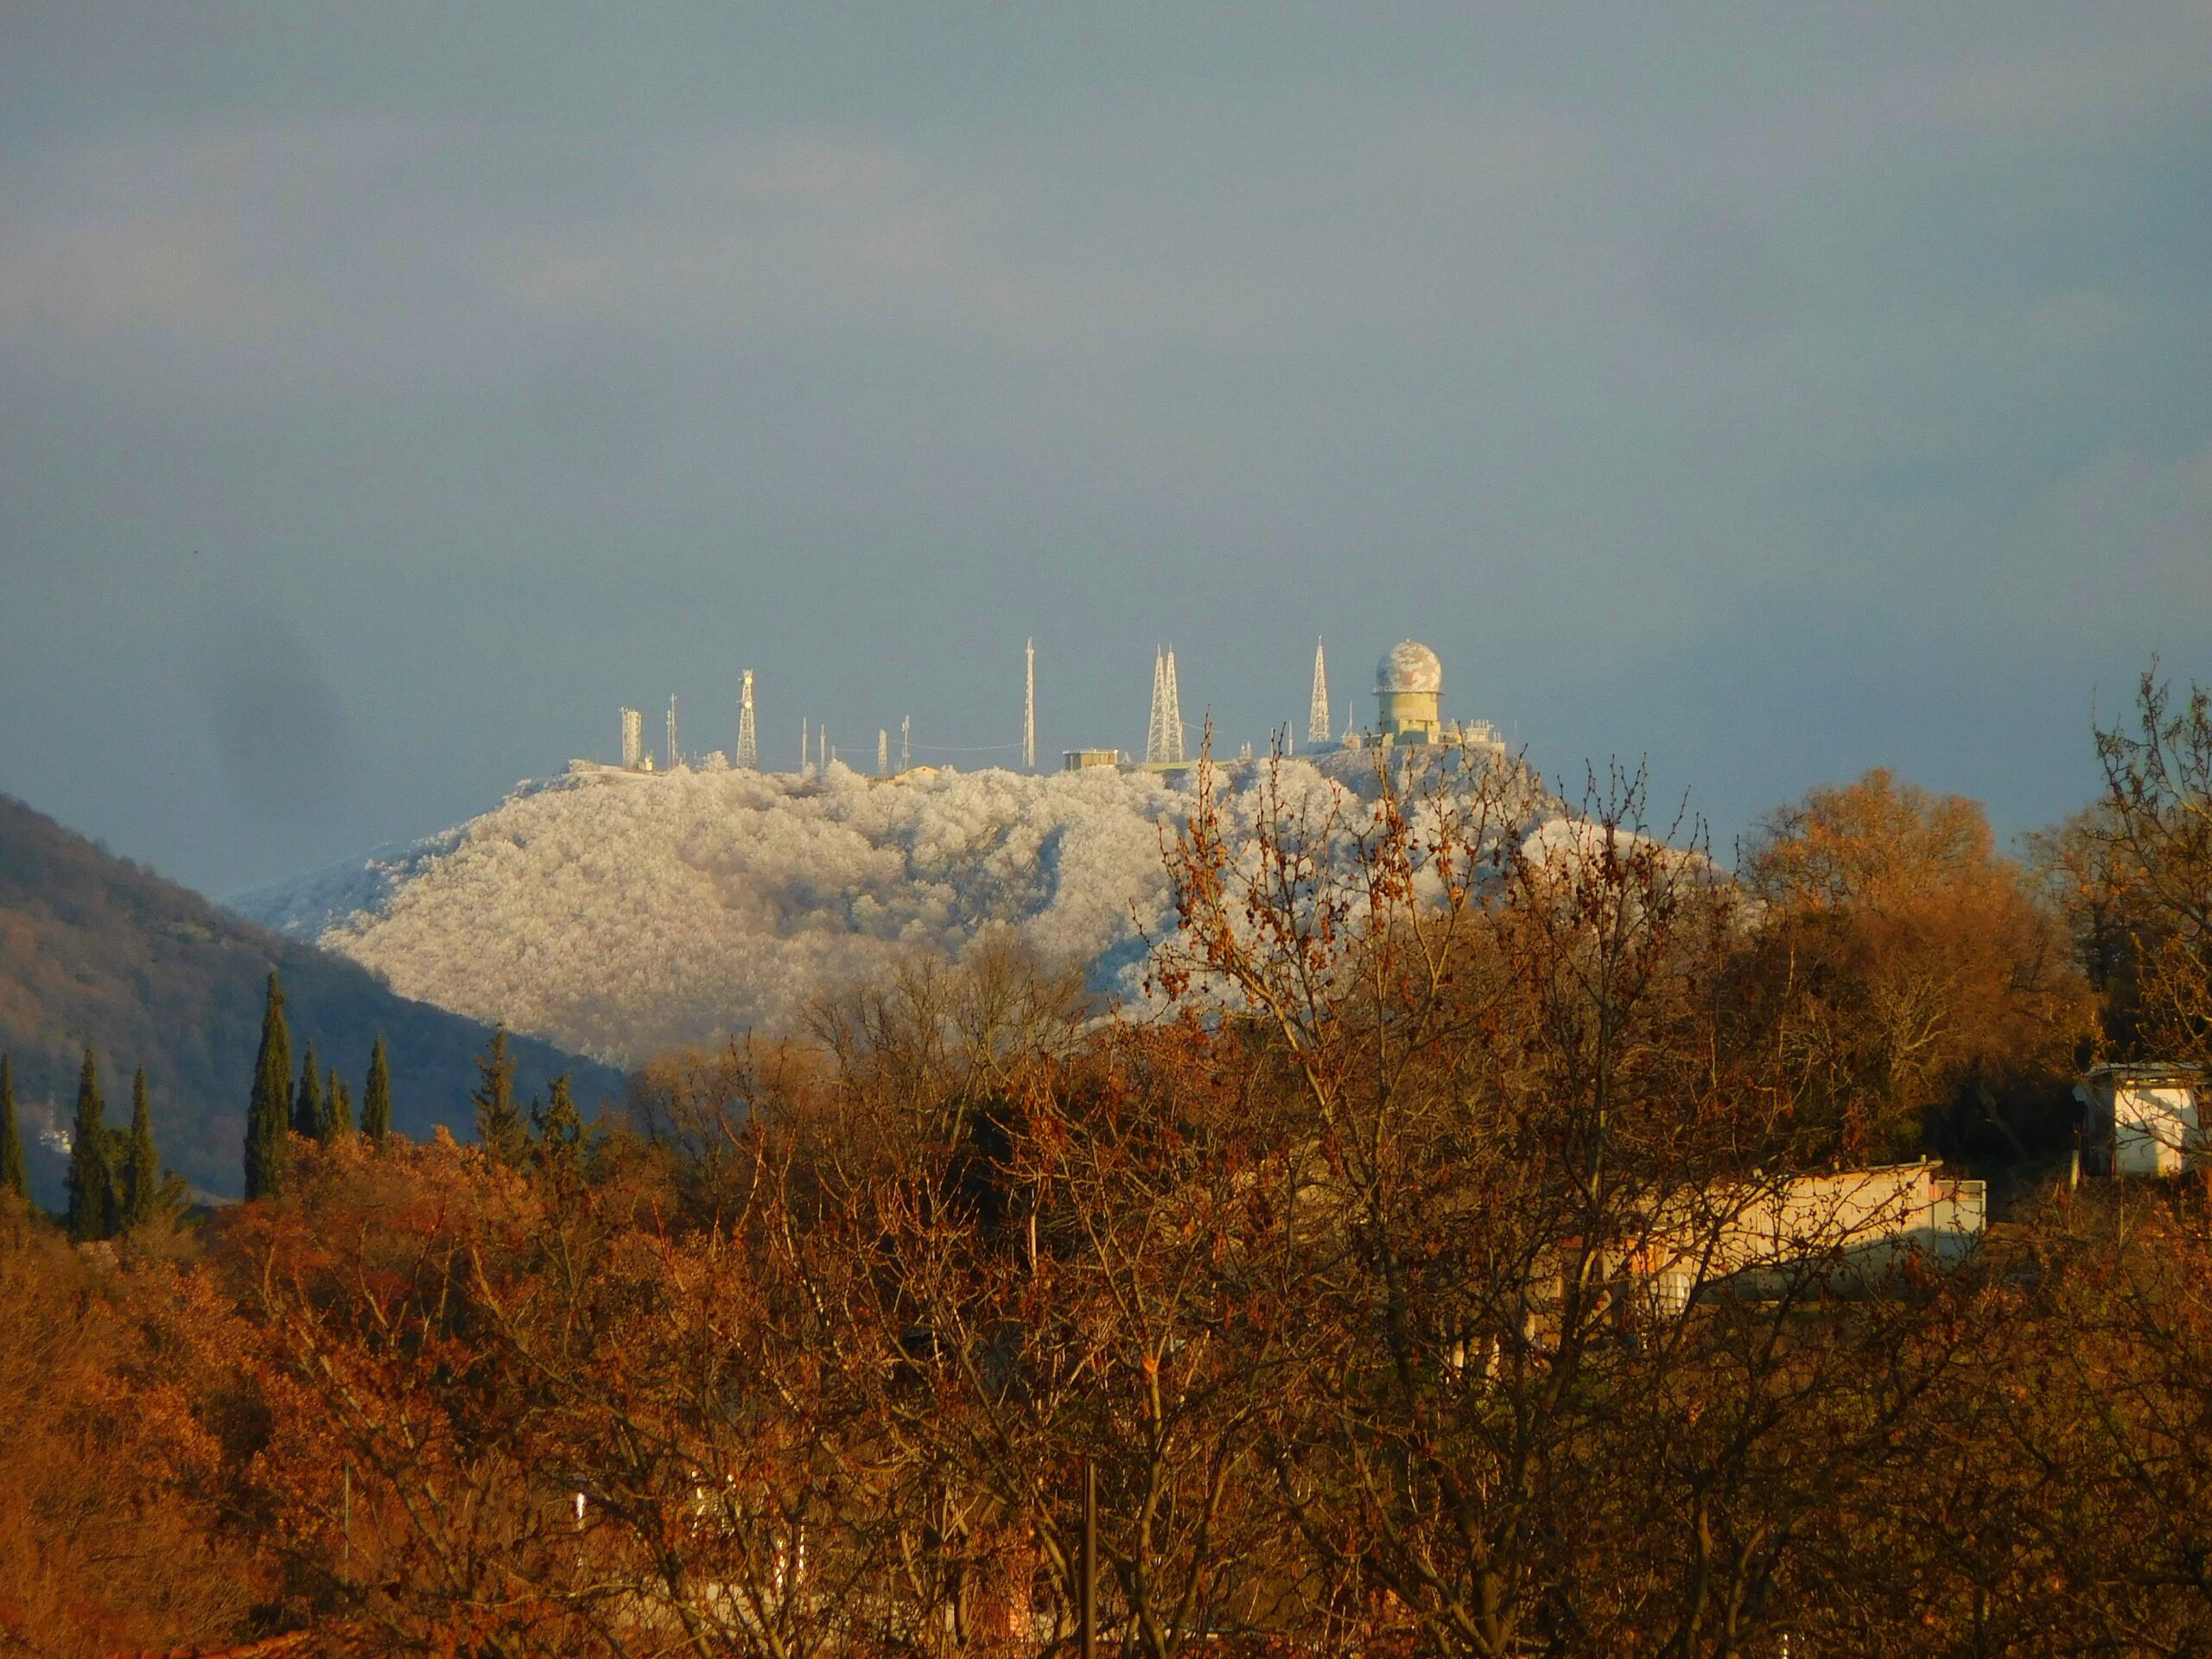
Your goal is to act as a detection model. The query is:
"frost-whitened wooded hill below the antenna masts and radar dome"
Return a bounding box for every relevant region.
[232,754,1548,1059]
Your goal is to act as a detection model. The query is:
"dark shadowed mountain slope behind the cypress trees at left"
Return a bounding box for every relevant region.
[0,797,621,1204]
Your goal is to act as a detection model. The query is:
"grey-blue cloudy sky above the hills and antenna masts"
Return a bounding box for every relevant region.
[0,0,2212,896]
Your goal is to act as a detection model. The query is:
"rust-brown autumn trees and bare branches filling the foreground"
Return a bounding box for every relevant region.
[0,668,2212,1659]
